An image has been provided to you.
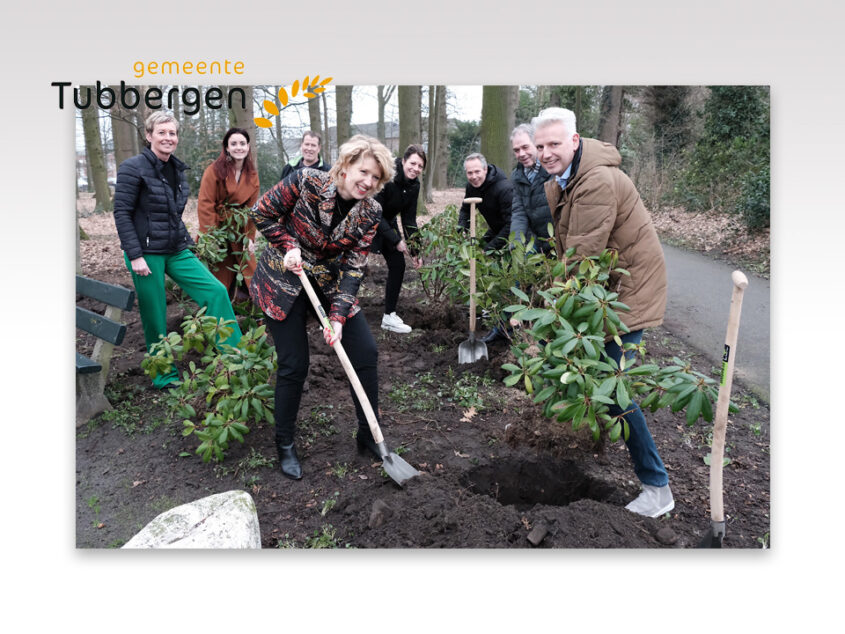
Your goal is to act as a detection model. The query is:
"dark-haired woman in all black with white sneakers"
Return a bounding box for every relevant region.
[373,145,426,334]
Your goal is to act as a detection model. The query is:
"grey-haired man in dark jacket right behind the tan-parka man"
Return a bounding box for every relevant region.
[511,123,552,253]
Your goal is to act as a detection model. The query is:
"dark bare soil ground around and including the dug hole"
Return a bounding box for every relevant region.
[76,190,770,548]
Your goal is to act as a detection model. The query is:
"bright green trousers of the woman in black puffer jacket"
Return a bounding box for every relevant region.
[123,249,242,387]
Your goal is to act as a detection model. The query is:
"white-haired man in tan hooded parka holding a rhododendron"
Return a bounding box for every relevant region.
[531,108,675,517]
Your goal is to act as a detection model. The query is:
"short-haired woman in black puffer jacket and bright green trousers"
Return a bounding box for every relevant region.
[114,111,241,388]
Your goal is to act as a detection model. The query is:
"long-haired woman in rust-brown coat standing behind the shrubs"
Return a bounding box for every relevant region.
[197,128,258,301]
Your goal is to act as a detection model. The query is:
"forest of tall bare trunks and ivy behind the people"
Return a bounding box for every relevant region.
[76,82,770,276]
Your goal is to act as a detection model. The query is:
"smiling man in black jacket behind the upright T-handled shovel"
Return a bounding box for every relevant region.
[458,152,513,343]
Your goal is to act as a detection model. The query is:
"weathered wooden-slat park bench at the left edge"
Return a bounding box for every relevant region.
[76,275,135,427]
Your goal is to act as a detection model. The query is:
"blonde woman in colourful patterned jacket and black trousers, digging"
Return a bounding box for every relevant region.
[250,135,393,480]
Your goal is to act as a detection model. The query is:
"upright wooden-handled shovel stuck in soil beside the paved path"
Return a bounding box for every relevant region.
[698,271,748,548]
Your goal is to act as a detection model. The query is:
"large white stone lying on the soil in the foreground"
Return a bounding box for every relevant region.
[123,491,261,548]
